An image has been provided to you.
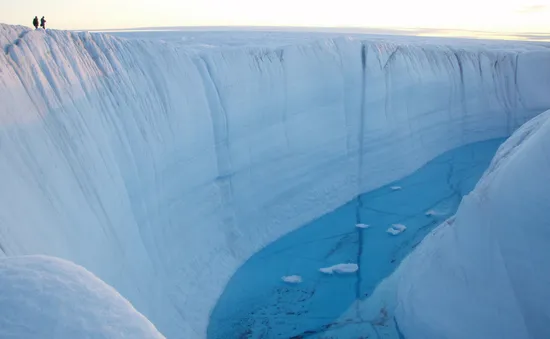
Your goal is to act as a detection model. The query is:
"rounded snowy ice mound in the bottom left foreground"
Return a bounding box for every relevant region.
[0,256,164,339]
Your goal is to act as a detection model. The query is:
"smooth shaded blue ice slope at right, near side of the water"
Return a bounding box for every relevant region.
[396,111,550,339]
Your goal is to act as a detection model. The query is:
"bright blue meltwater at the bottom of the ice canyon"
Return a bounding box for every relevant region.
[208,139,504,339]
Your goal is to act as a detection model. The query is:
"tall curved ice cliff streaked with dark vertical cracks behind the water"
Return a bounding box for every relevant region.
[0,26,550,338]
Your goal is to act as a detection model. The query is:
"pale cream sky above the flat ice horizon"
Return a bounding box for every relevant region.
[0,0,550,34]
